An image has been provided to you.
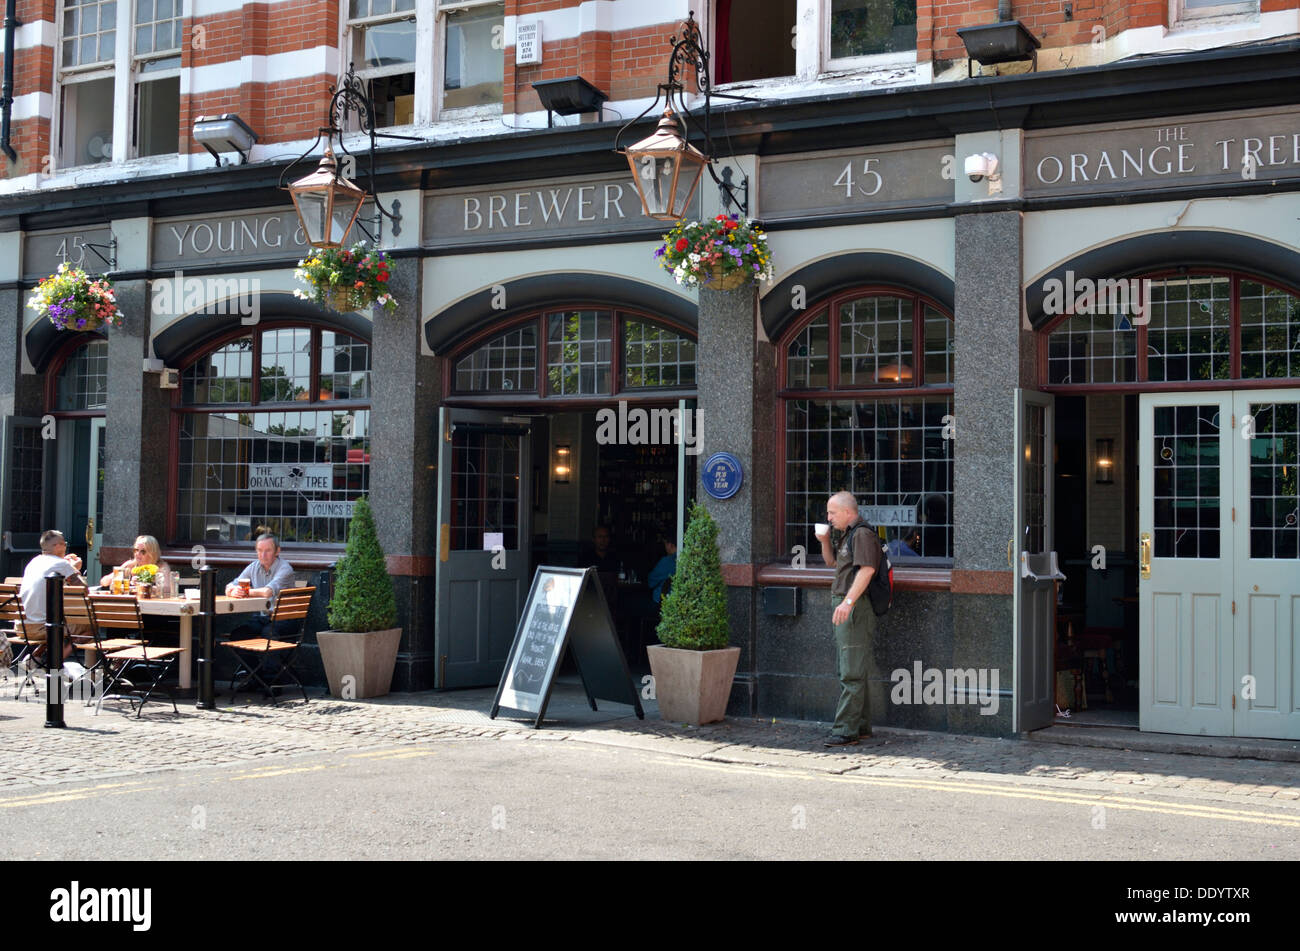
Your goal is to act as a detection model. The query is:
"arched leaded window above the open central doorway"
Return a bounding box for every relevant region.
[451,308,696,399]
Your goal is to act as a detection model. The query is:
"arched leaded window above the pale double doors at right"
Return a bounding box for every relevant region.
[1044,270,1300,387]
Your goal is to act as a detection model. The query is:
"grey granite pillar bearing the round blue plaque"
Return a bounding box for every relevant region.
[696,285,776,716]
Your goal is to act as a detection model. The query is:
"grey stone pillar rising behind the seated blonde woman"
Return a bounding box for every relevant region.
[101,281,172,565]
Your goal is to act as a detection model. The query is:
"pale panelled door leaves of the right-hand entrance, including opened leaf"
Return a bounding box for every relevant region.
[1008,388,1300,739]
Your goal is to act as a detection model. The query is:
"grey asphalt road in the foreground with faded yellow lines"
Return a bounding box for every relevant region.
[12,734,1300,861]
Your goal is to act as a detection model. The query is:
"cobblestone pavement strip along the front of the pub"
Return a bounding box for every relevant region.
[0,690,1300,815]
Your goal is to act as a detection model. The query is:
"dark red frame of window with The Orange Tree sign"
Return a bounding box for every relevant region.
[166,318,374,550]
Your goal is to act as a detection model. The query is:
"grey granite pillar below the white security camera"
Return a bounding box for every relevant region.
[948,212,1032,734]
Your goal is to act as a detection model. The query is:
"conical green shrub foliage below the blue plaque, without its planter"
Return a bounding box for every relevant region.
[658,501,729,651]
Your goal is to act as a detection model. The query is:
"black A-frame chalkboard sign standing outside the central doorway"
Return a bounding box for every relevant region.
[490,565,645,729]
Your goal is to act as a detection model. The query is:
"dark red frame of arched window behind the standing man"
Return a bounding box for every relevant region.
[774,283,958,561]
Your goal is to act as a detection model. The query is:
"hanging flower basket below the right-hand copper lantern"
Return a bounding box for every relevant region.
[654,214,772,291]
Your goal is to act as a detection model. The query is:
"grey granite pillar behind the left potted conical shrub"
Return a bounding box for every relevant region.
[371,257,442,690]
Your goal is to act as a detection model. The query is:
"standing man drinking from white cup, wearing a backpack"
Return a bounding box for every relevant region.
[819,492,880,746]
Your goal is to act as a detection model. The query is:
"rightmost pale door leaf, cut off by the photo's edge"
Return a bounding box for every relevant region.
[1232,390,1300,739]
